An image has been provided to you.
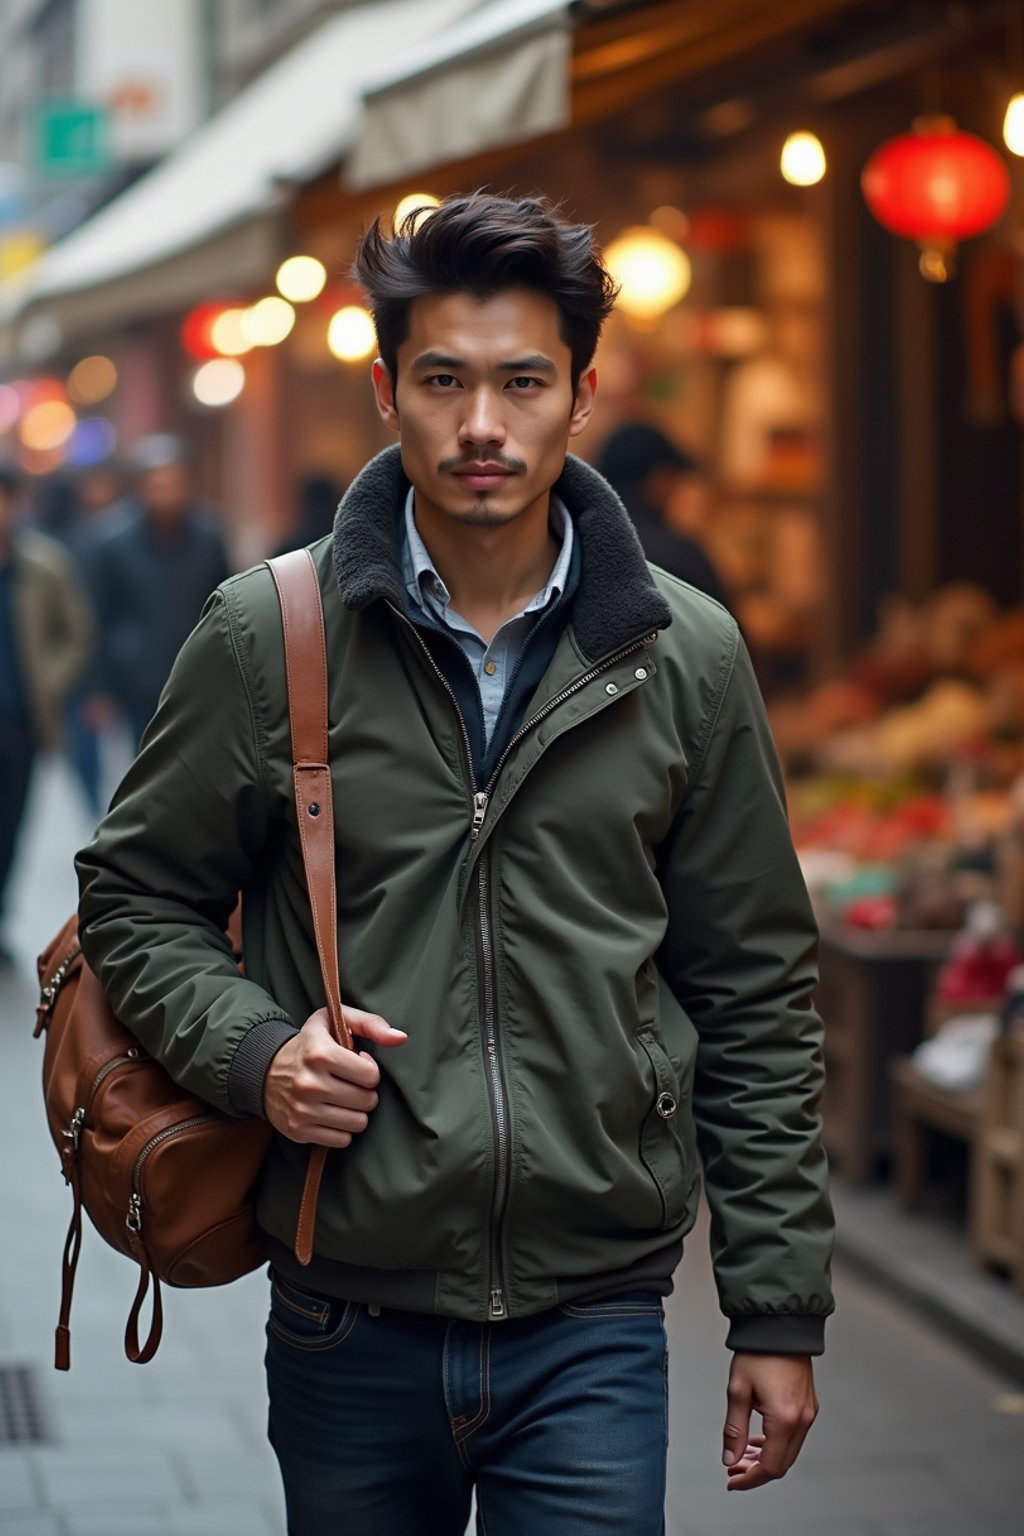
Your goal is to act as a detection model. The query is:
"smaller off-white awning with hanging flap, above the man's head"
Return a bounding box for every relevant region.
[344,0,571,189]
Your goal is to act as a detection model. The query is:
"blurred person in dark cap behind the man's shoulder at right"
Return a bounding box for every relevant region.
[597,421,729,608]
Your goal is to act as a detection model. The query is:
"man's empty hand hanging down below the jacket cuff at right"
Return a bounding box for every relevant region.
[722,1352,818,1490]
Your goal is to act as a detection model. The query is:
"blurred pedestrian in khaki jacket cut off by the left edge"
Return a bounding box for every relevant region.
[0,467,94,965]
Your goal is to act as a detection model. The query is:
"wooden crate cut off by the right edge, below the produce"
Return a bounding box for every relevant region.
[970,1031,1024,1290]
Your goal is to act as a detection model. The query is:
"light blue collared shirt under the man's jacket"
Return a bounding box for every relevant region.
[402,488,573,745]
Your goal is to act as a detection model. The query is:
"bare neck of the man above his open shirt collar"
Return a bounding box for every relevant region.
[415,492,559,644]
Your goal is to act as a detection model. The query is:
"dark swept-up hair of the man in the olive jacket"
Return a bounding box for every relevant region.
[353,192,617,389]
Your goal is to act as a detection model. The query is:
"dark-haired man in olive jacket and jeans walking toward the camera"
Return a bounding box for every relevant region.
[80,194,831,1536]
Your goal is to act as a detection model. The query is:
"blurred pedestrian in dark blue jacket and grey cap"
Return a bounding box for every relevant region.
[86,433,229,743]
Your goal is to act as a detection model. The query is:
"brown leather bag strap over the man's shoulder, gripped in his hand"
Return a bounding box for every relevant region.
[267,550,353,1264]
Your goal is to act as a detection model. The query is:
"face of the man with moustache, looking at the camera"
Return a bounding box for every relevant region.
[373,289,596,527]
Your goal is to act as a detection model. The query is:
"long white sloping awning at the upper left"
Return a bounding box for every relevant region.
[0,0,473,339]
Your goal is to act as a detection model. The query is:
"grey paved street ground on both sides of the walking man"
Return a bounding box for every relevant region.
[0,768,1024,1536]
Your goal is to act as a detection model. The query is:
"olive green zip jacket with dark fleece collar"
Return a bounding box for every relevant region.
[78,449,832,1353]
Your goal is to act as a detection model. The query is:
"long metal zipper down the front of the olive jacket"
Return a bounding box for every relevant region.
[388,604,654,1322]
